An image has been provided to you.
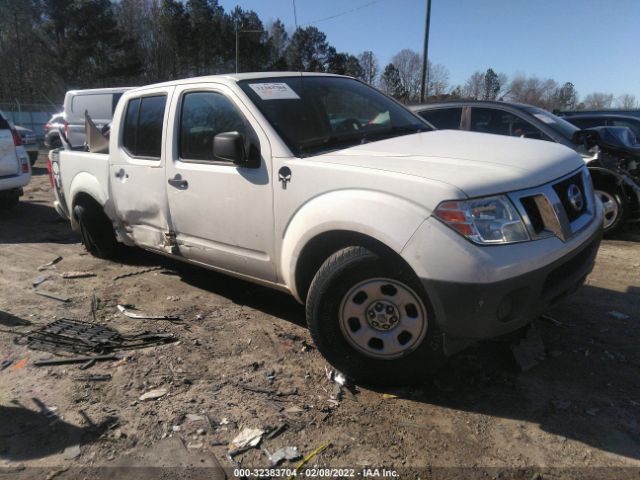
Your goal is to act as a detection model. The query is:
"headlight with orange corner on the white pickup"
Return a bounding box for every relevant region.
[434,195,529,245]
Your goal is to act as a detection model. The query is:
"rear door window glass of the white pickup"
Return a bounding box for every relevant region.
[122,95,167,159]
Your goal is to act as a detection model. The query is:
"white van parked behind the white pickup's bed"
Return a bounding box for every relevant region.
[64,87,132,147]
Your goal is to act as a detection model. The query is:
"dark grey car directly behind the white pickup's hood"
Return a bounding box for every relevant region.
[411,101,640,233]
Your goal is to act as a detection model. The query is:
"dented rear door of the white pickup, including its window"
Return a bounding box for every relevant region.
[109,87,173,250]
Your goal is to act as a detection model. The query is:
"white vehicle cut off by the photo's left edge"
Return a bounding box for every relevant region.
[0,112,31,207]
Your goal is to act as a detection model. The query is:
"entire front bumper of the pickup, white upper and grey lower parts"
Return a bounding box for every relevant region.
[402,197,602,346]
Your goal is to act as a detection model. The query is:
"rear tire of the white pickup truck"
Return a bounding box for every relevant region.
[73,204,120,259]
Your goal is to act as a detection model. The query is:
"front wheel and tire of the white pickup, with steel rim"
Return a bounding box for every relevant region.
[306,247,445,386]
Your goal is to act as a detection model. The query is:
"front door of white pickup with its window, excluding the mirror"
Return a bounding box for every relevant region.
[166,83,276,281]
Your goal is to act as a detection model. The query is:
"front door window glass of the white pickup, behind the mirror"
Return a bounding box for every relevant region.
[179,92,252,162]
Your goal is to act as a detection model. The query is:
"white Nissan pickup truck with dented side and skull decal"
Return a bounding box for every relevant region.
[51,73,602,384]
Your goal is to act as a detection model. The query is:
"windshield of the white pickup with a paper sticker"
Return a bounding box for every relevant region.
[238,76,432,157]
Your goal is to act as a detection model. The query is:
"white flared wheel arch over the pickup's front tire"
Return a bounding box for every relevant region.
[280,190,431,300]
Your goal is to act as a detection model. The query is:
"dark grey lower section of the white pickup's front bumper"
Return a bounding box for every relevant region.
[422,229,602,340]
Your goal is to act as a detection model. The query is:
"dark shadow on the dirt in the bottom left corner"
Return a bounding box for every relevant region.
[0,398,116,461]
